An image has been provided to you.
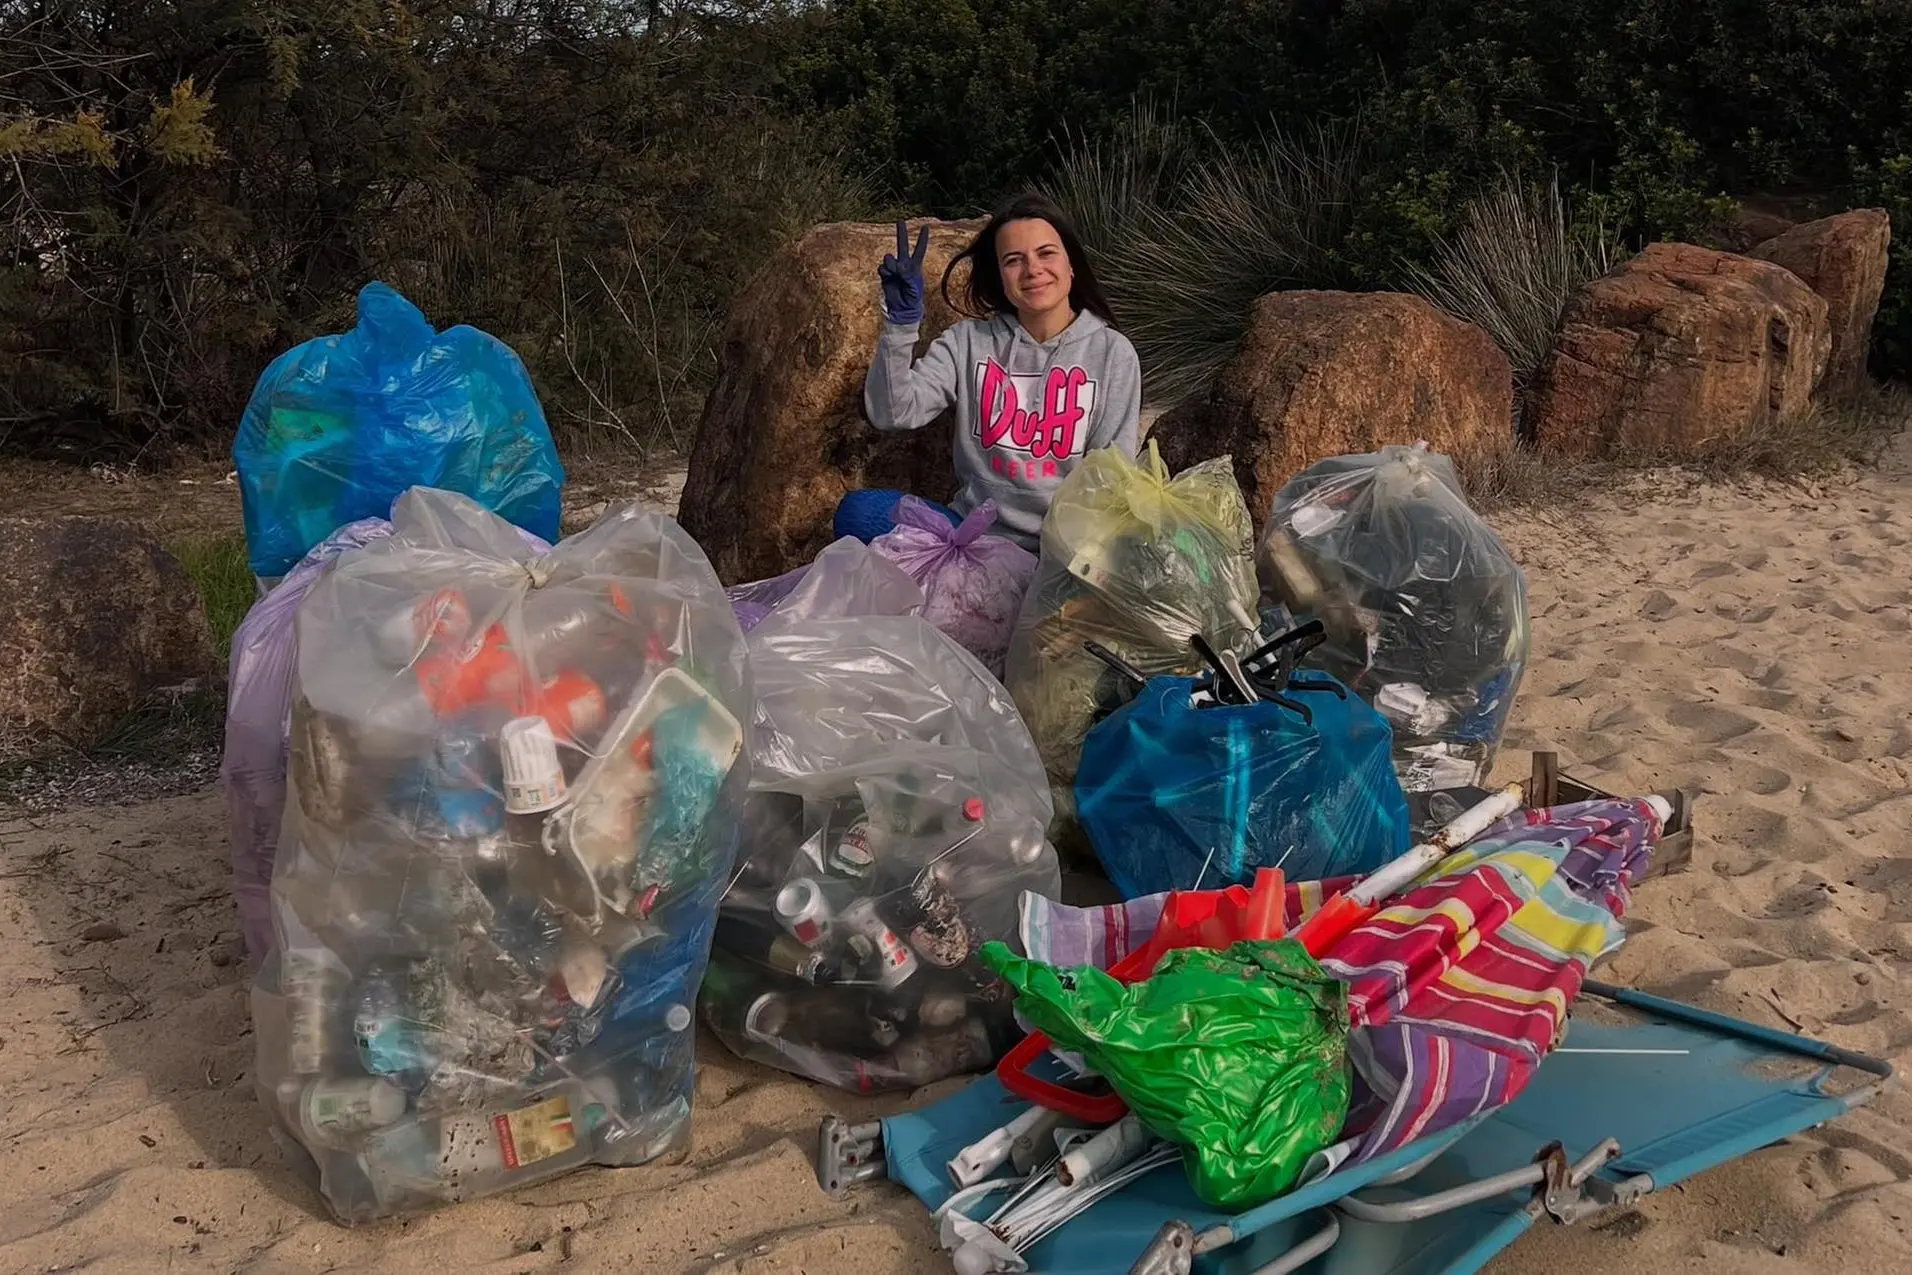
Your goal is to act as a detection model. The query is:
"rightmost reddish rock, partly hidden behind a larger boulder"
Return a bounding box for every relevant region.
[1749,208,1893,394]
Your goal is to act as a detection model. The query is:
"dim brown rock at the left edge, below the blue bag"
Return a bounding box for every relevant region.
[0,518,218,751]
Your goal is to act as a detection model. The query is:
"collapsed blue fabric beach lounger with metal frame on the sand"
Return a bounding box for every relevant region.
[816,981,1893,1275]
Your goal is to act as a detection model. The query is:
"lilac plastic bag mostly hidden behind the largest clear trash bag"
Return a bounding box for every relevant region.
[220,518,551,965]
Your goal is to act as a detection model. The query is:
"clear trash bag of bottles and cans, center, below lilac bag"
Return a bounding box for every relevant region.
[702,617,1061,1091]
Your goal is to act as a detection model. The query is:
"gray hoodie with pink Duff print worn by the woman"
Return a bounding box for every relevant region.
[862,312,1141,549]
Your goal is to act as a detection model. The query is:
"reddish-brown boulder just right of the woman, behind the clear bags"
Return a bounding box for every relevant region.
[1153,292,1514,526]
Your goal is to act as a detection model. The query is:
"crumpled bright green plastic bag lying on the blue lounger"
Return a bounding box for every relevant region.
[983,939,1350,1210]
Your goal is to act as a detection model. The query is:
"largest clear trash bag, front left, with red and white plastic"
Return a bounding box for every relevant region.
[252,489,751,1223]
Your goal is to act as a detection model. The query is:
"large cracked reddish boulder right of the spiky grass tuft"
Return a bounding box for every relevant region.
[1533,243,1832,459]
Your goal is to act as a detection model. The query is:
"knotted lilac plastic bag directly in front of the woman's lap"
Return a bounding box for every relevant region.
[870,495,1036,679]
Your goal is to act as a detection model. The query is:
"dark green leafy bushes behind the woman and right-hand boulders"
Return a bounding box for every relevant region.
[786,0,1912,377]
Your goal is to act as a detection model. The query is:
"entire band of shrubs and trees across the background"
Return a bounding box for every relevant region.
[0,0,1912,464]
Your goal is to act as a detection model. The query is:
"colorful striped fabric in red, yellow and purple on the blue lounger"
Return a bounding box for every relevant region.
[1021,801,1662,1160]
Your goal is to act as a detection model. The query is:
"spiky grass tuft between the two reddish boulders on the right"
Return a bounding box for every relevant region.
[1405,174,1623,426]
